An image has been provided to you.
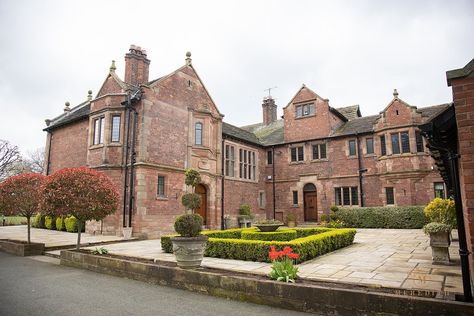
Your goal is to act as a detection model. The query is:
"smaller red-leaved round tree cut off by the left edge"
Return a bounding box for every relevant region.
[0,173,46,243]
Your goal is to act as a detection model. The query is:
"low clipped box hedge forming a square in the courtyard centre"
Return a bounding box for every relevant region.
[161,228,356,262]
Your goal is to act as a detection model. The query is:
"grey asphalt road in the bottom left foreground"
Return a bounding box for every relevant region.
[0,252,307,316]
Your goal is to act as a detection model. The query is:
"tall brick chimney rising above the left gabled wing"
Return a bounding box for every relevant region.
[125,45,150,86]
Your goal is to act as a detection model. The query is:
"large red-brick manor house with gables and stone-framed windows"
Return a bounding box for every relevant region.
[44,45,449,238]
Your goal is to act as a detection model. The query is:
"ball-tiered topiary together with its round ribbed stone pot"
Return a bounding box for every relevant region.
[171,169,208,269]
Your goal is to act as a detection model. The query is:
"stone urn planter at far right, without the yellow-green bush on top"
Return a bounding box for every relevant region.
[423,223,451,264]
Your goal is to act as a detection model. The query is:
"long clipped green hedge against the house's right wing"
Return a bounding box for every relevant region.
[333,206,429,229]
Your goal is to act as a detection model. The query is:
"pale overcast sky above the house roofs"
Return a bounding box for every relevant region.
[0,0,474,152]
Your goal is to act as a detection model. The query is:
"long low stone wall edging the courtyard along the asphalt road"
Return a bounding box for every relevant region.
[61,250,474,316]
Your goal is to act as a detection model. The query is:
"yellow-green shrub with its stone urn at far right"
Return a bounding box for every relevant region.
[423,198,456,264]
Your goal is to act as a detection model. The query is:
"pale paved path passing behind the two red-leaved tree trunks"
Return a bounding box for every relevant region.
[0,225,128,248]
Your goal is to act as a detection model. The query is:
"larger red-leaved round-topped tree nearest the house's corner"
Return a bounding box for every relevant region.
[41,167,119,249]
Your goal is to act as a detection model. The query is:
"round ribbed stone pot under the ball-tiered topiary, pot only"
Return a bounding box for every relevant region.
[171,235,208,269]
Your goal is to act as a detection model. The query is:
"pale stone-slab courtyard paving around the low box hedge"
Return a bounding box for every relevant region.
[82,229,462,295]
